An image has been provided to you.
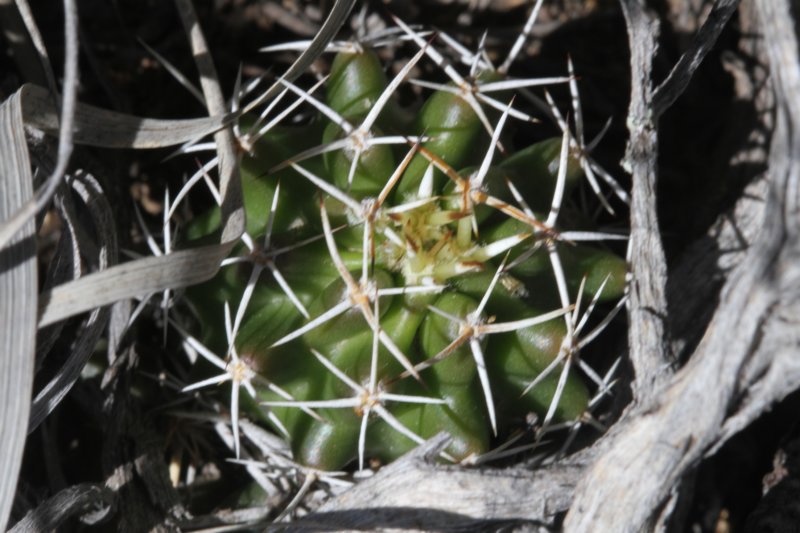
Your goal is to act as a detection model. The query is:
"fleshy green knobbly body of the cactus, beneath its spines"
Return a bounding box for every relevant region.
[187,44,625,469]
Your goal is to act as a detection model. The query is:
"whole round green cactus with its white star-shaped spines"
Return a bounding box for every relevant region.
[178,22,625,470]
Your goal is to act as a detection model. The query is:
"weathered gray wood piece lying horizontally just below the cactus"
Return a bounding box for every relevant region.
[296,435,585,531]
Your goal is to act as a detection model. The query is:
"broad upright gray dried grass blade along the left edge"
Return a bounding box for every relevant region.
[0,92,38,531]
